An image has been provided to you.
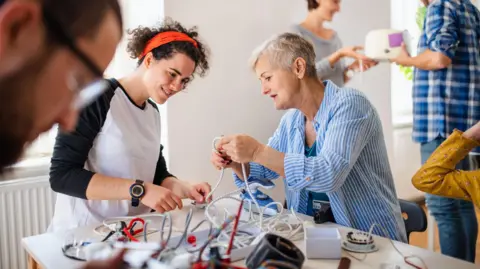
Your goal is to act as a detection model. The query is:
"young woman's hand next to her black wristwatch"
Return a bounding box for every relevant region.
[140,183,183,213]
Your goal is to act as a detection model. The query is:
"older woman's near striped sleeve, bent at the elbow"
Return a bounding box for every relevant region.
[284,96,380,192]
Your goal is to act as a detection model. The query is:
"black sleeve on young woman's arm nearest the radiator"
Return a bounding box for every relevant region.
[50,80,116,199]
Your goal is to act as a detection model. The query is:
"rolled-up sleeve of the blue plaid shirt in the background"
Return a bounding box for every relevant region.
[425,1,458,59]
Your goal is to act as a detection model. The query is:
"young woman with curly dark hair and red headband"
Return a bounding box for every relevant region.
[49,19,210,231]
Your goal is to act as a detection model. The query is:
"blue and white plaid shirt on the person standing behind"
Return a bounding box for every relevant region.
[413,0,480,149]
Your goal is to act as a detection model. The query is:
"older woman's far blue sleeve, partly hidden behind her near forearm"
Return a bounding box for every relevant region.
[233,116,286,187]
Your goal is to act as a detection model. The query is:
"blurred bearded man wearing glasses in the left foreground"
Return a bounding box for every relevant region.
[0,0,126,269]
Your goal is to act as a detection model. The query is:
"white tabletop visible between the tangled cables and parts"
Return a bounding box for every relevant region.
[22,200,477,269]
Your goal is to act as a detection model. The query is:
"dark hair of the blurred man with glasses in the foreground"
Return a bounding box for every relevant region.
[42,0,123,38]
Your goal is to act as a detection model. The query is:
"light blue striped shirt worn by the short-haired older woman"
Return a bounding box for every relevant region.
[234,80,407,242]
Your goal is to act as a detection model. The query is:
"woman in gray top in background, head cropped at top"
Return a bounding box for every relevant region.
[292,0,377,87]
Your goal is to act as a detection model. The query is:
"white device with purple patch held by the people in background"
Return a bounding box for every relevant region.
[364,29,412,61]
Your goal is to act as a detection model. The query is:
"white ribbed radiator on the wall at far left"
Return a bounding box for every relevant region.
[0,176,55,269]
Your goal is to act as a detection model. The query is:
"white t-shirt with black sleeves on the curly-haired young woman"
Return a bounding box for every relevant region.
[49,79,172,231]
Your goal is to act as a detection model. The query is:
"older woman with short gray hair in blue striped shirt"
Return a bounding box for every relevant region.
[211,33,407,242]
